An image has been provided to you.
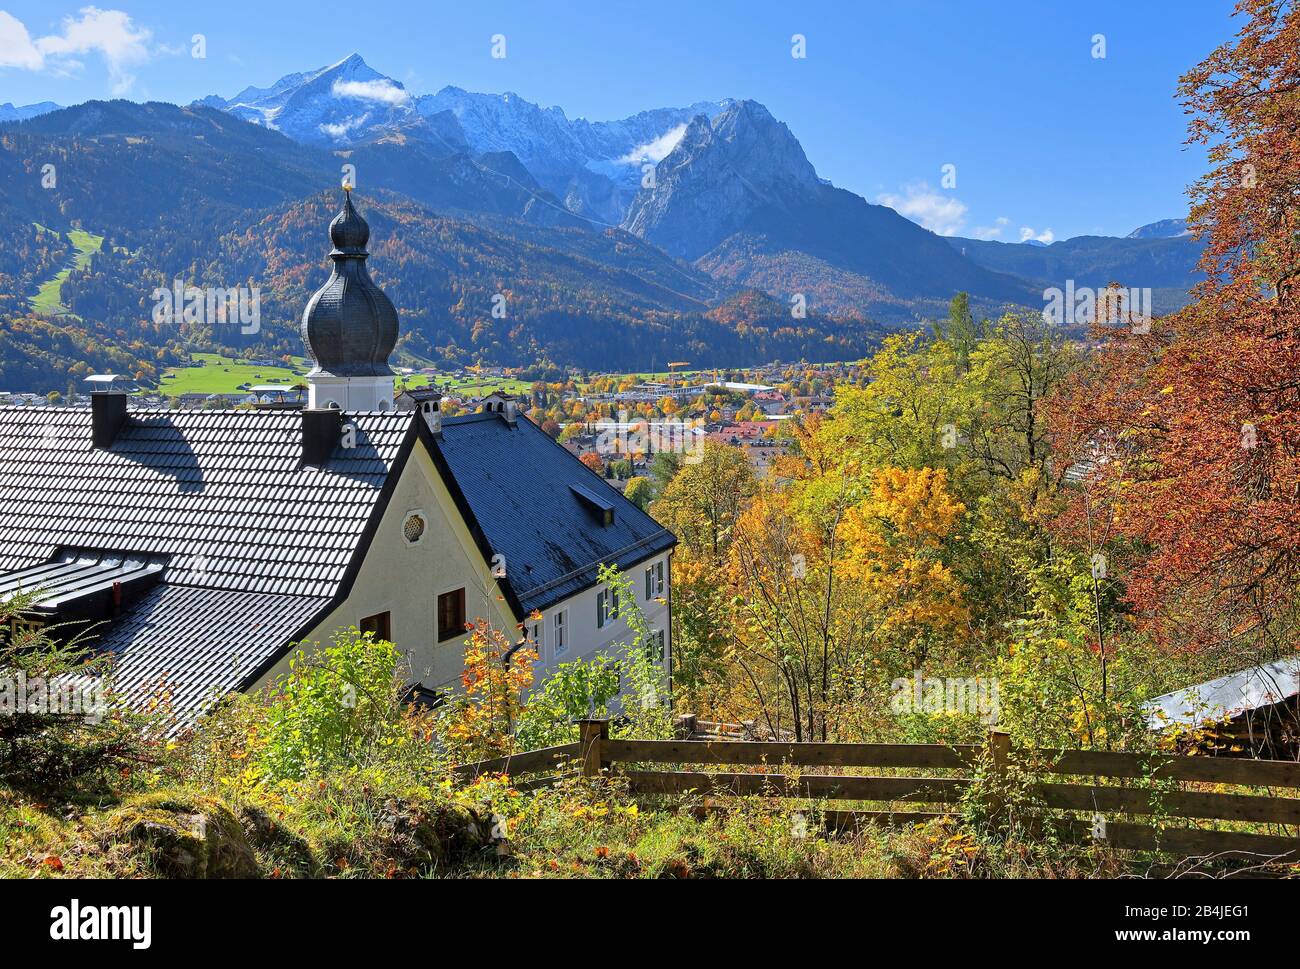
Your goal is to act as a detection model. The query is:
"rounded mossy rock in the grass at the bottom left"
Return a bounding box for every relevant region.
[100,791,259,878]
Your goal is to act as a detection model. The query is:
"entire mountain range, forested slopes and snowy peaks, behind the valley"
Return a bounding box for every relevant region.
[0,55,1196,386]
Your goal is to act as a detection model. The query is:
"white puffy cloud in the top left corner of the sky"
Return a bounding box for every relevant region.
[0,7,153,95]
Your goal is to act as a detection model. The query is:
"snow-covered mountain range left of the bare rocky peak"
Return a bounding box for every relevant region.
[199,53,728,225]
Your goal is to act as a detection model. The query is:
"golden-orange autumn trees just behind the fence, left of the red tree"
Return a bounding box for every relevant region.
[727,467,966,740]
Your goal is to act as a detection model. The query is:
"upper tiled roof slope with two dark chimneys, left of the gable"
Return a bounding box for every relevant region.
[0,407,415,598]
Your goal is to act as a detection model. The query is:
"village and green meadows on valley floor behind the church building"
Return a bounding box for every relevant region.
[0,352,842,490]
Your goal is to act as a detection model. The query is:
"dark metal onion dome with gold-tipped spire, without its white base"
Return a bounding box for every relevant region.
[303,192,398,377]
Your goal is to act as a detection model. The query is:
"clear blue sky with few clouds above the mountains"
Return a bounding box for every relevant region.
[0,0,1235,242]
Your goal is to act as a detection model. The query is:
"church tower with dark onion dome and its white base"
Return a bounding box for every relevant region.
[303,191,398,411]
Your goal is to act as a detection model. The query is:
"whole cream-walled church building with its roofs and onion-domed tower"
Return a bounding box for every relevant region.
[0,191,676,723]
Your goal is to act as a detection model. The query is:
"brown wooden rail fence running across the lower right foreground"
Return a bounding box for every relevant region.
[455,721,1300,861]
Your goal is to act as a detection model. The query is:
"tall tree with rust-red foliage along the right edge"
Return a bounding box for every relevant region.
[1050,0,1300,652]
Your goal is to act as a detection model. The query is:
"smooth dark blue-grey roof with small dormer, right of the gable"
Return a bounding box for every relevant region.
[436,414,677,618]
